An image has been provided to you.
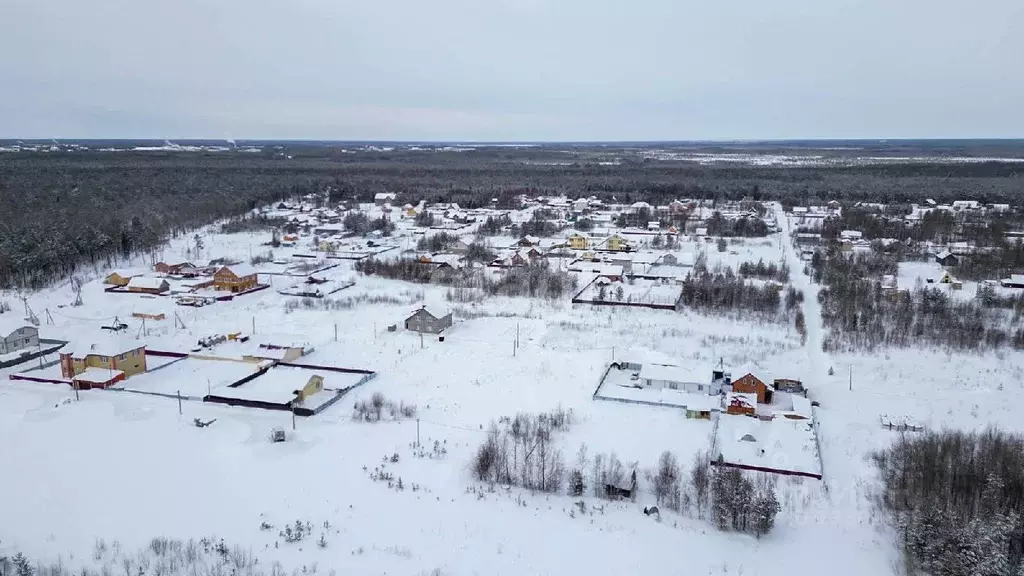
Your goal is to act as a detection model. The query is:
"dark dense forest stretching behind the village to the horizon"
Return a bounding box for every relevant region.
[0,145,1024,288]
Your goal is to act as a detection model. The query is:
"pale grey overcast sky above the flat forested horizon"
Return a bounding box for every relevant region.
[0,0,1024,140]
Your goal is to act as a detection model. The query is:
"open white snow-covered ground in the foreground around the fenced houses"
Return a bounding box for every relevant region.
[6,203,1024,576]
